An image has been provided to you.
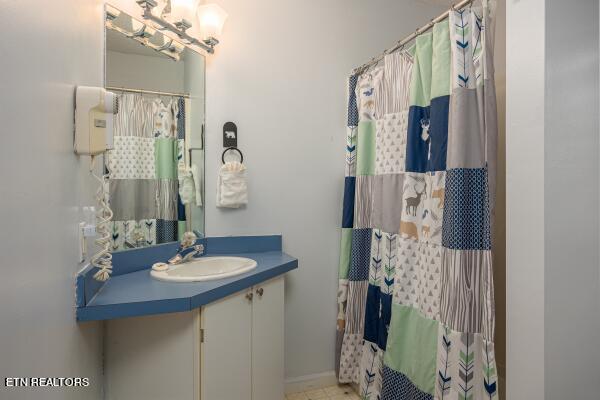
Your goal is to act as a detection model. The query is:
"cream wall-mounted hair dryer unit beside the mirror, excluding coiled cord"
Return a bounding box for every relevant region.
[75,86,119,156]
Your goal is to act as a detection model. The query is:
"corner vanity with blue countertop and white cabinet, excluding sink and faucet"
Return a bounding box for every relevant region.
[77,236,298,400]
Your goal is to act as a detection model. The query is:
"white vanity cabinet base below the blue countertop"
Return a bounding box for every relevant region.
[105,277,284,400]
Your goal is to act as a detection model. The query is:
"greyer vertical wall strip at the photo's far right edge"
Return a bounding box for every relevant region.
[544,0,600,400]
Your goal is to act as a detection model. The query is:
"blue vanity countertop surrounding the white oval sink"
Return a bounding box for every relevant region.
[77,237,298,321]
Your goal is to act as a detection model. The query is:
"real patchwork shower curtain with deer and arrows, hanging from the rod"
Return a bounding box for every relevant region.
[337,1,498,400]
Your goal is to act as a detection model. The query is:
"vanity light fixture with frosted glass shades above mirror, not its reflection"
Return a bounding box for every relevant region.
[136,0,227,54]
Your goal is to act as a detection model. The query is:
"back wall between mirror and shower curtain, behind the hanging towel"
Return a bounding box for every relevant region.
[206,0,442,378]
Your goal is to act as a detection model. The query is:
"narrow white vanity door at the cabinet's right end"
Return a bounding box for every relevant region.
[252,277,284,400]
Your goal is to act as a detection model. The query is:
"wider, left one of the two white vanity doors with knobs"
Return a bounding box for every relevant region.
[200,289,253,400]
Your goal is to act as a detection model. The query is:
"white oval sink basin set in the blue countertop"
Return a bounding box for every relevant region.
[150,257,256,282]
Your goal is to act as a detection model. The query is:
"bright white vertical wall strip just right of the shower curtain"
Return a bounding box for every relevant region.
[506,0,545,400]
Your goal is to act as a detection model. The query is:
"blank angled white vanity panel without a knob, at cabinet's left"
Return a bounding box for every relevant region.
[104,310,200,400]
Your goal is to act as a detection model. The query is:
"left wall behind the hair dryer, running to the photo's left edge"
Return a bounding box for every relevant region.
[0,0,103,400]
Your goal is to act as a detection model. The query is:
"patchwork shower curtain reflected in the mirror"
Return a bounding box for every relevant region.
[108,94,185,250]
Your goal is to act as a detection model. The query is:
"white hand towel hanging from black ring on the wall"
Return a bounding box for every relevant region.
[217,161,248,208]
